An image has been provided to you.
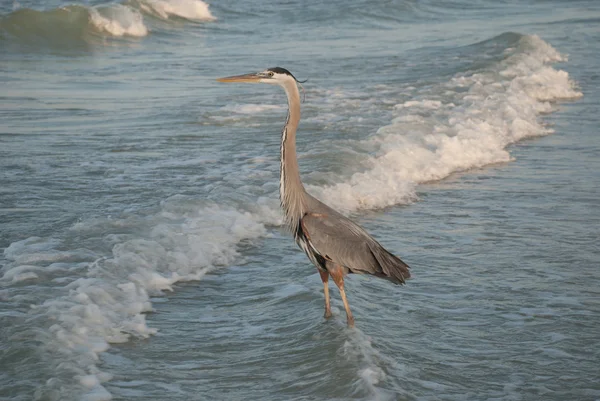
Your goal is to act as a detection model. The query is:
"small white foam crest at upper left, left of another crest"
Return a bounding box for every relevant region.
[89,4,148,37]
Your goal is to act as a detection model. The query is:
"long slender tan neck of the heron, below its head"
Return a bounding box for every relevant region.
[279,80,306,233]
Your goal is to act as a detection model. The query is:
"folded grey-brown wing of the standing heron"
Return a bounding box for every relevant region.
[300,209,410,284]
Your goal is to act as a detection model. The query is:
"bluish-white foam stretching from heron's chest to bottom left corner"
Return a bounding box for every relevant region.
[0,196,270,400]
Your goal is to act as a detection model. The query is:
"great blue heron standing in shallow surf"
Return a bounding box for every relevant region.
[217,67,410,327]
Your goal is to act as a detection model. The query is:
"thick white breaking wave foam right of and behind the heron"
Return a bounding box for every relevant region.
[311,36,582,211]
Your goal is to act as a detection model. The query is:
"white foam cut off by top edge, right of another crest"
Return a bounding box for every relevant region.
[134,0,216,21]
